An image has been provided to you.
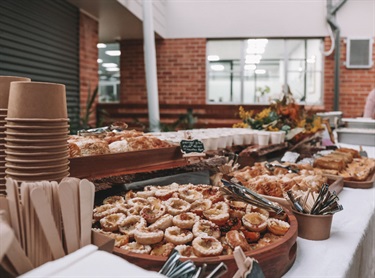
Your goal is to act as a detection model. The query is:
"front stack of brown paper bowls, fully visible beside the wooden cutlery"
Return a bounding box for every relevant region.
[5,82,69,184]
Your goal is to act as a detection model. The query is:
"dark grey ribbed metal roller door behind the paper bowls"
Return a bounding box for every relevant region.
[0,0,79,130]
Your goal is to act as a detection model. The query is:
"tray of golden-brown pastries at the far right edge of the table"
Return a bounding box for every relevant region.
[314,148,375,188]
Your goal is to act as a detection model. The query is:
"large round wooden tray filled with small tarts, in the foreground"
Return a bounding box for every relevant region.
[93,183,297,277]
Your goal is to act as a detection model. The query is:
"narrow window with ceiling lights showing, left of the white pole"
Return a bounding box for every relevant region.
[98,43,121,103]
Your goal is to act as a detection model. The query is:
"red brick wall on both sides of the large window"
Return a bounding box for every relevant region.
[121,38,375,117]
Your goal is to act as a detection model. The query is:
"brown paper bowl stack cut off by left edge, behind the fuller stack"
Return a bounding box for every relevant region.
[0,76,30,194]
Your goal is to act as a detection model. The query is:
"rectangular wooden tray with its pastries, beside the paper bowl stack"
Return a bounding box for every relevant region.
[68,130,186,178]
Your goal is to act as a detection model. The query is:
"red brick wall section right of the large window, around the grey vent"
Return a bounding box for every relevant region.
[324,38,375,117]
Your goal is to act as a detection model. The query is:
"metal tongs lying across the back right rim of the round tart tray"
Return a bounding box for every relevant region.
[221,179,284,214]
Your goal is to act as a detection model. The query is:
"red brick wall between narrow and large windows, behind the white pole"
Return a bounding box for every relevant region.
[120,39,206,104]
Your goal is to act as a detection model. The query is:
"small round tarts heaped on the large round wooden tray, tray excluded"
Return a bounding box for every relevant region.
[94,184,289,257]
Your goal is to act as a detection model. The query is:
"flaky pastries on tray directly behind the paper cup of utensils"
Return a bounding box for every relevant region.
[230,162,343,207]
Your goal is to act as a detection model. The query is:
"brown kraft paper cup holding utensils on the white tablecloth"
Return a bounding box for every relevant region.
[292,210,333,240]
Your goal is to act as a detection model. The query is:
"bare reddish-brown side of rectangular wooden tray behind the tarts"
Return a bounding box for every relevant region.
[69,146,187,178]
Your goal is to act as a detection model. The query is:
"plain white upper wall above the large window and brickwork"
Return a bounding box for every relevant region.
[165,0,375,38]
